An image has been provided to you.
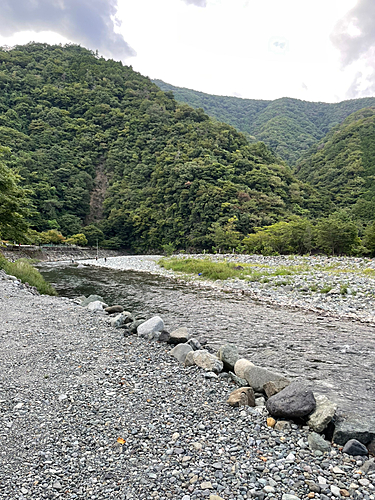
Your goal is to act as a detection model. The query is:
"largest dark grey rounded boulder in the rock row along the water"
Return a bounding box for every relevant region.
[266,382,316,419]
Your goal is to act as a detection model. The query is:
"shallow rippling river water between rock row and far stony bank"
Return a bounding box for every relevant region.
[39,263,375,416]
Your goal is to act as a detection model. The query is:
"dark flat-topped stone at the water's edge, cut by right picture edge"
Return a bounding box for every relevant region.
[333,417,375,445]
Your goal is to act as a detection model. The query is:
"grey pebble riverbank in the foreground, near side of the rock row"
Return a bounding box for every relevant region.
[0,272,375,500]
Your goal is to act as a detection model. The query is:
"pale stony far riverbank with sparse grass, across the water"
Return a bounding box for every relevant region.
[82,254,375,326]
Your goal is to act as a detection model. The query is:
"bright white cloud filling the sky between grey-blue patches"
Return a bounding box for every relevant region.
[0,0,372,102]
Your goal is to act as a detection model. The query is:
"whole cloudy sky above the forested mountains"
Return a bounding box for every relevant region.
[0,0,375,102]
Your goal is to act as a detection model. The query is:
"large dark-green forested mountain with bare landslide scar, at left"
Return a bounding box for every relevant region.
[0,43,329,250]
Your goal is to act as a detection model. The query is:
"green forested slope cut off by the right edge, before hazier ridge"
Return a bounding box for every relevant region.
[296,107,375,222]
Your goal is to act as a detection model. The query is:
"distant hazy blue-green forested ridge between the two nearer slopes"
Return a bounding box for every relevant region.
[153,80,375,166]
